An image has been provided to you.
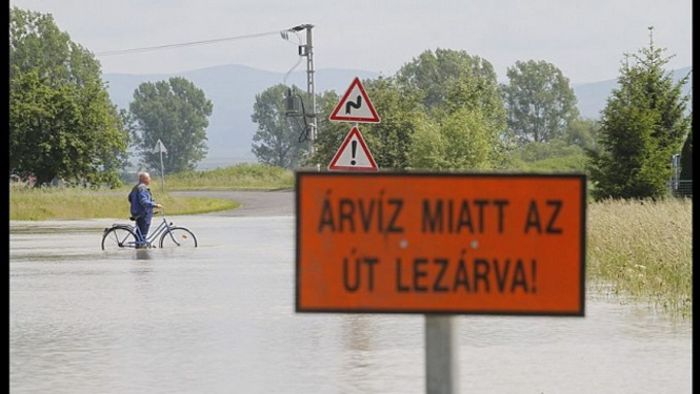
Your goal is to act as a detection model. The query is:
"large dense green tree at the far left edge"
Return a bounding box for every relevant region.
[9,7,128,186]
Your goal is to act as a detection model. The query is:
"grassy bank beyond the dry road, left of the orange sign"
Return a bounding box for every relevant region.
[153,164,294,190]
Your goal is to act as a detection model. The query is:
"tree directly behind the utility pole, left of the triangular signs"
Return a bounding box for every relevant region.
[251,84,311,168]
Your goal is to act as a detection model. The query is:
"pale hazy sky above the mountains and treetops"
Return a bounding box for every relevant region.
[10,0,692,83]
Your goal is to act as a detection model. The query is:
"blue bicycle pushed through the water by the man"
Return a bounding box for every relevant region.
[102,209,197,250]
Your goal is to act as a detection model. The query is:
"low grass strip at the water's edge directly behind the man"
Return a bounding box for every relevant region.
[10,185,239,220]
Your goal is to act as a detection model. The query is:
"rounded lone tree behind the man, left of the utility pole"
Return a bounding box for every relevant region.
[129,77,213,172]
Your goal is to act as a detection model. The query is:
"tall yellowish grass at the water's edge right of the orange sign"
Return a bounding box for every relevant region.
[587,199,693,316]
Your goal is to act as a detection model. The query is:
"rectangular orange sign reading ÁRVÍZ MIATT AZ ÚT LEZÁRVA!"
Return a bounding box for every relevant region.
[296,172,586,316]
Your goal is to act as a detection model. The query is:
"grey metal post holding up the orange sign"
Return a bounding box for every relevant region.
[425,315,459,394]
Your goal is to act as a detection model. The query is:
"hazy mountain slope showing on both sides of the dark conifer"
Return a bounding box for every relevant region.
[572,67,693,119]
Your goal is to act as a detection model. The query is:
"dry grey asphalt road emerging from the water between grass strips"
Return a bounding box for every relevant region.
[171,190,294,217]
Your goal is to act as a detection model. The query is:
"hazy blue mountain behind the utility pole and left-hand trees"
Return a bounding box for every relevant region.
[103,65,379,169]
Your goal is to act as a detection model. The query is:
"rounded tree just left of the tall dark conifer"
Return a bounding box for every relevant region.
[502,60,578,144]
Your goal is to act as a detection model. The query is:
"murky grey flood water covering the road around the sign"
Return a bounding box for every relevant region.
[10,216,692,393]
